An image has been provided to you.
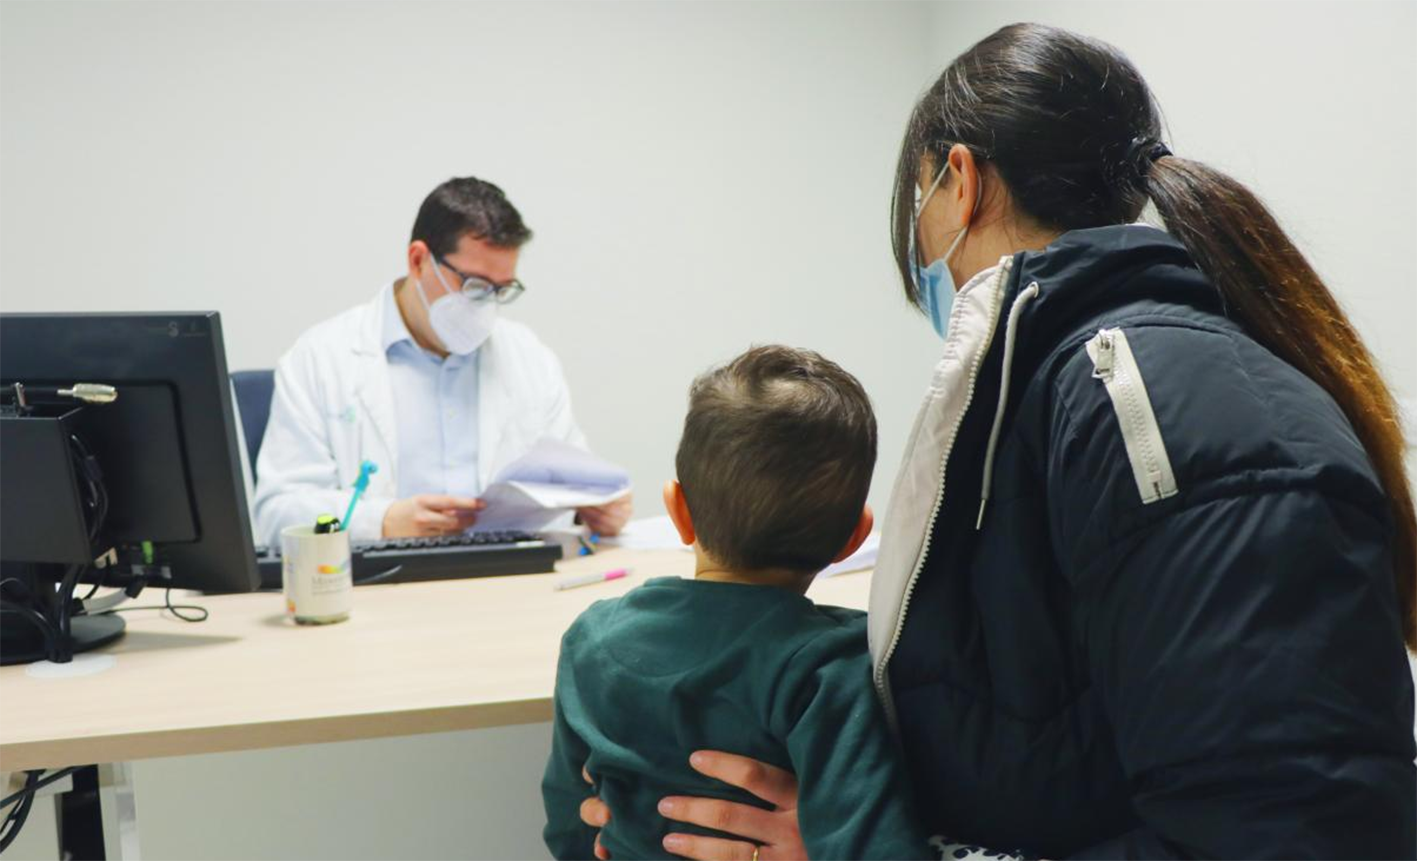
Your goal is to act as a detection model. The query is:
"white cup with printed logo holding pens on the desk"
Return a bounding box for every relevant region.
[281,527,354,625]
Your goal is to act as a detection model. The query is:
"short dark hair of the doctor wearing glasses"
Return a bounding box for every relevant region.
[410,177,531,256]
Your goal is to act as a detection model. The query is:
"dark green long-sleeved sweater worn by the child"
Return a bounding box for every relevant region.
[541,578,938,861]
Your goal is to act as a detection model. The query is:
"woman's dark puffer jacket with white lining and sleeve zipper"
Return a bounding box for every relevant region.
[871,225,1417,861]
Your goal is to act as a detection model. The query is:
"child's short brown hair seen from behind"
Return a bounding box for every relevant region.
[674,346,876,574]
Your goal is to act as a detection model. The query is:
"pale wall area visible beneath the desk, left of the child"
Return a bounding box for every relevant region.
[133,724,551,861]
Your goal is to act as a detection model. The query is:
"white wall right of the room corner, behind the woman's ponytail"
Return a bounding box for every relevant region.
[931,0,1417,397]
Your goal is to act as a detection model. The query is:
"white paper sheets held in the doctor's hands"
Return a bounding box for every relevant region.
[476,439,629,531]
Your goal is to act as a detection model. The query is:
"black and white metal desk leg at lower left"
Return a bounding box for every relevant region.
[60,762,139,861]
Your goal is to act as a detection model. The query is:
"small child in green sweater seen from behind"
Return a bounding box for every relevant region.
[541,347,938,861]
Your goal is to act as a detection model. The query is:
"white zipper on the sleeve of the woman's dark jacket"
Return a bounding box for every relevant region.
[1087,329,1179,506]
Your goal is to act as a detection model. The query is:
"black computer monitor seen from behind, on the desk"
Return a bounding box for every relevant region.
[0,312,259,663]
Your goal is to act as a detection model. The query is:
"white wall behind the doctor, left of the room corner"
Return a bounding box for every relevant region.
[0,0,938,523]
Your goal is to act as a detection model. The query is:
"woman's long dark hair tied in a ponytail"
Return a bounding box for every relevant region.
[891,24,1417,650]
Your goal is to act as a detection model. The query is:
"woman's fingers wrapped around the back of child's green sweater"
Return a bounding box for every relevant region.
[657,751,806,861]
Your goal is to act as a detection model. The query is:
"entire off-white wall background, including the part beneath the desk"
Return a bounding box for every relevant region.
[0,0,1417,861]
